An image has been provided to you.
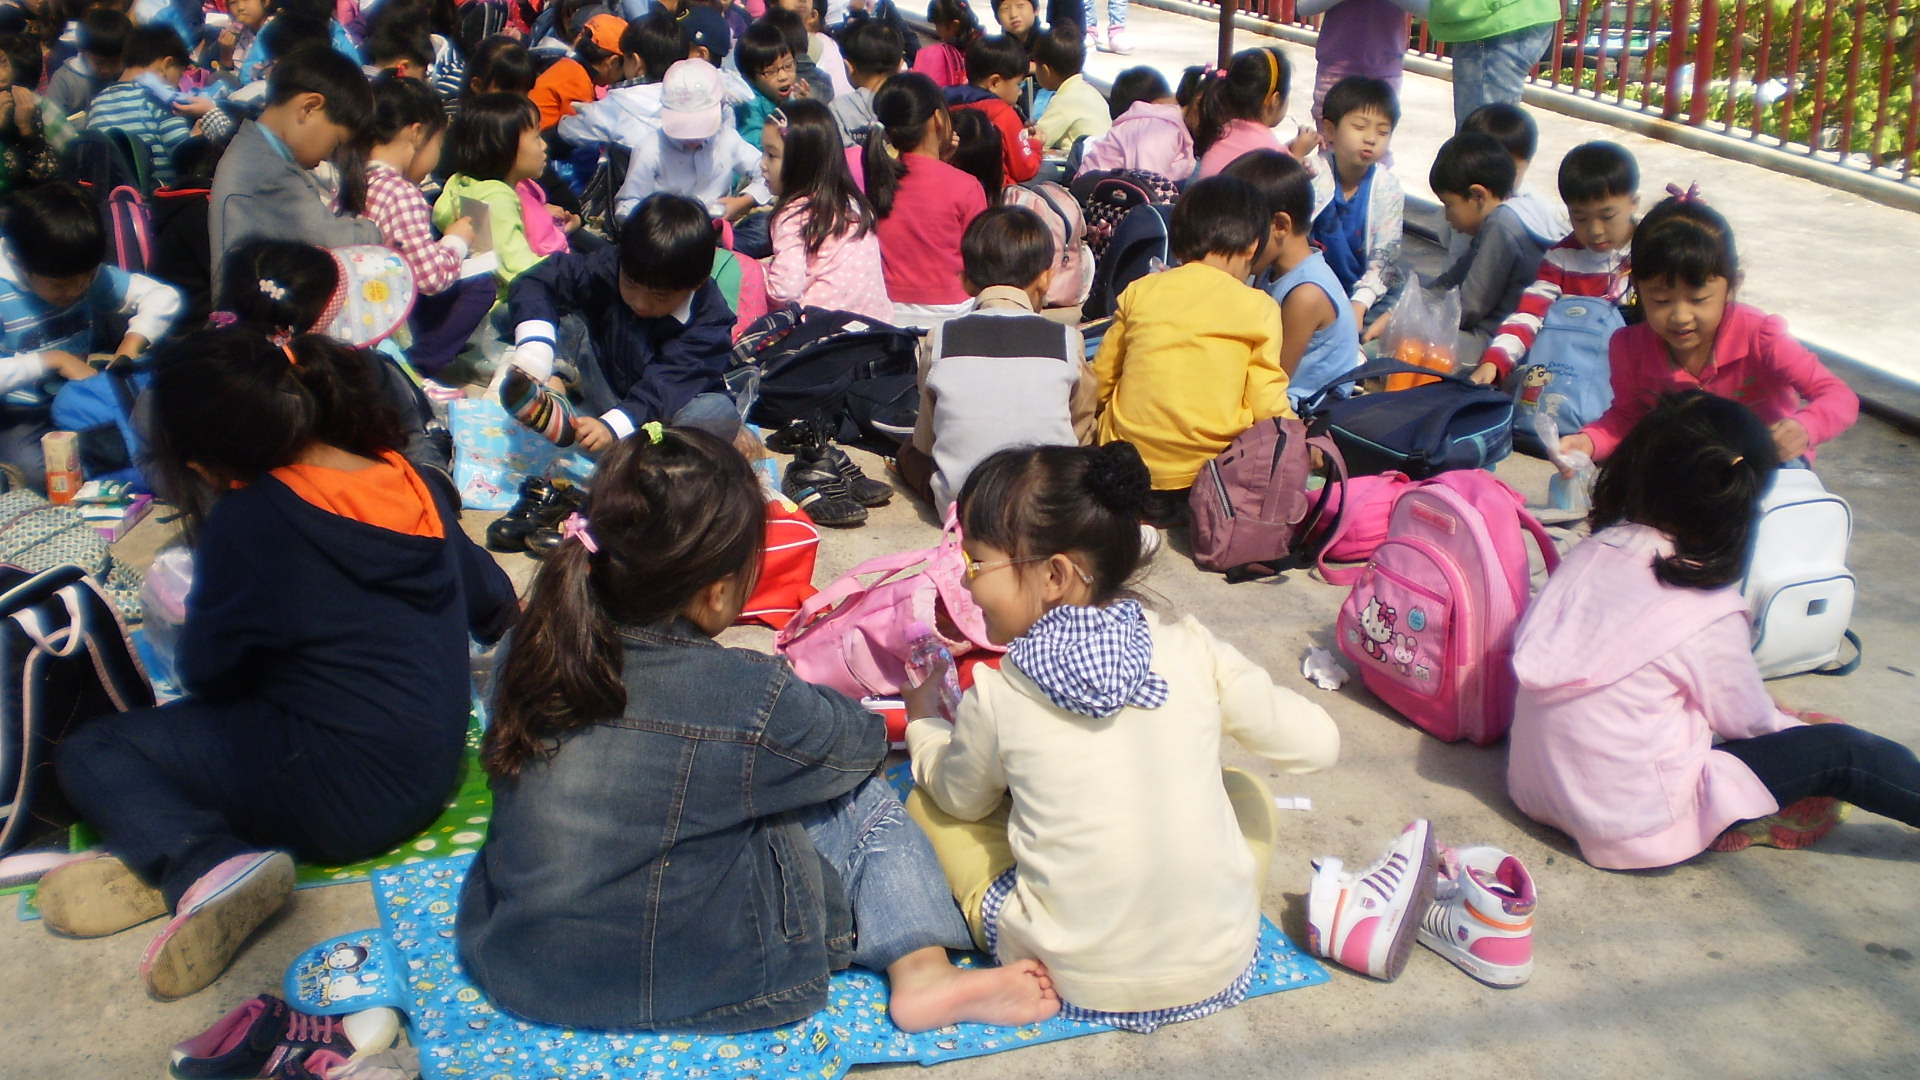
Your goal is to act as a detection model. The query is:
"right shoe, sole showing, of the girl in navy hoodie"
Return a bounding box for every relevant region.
[140,851,294,1001]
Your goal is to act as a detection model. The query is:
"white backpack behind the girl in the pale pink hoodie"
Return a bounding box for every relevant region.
[1740,469,1860,678]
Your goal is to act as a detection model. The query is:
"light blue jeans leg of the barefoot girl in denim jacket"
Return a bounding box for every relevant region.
[801,776,973,970]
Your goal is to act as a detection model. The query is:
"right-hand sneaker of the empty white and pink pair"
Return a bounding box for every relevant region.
[1421,847,1534,986]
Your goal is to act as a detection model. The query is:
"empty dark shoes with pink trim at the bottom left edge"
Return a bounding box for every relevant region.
[167,994,399,1080]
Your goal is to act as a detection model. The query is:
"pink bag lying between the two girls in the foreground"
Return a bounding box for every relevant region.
[774,509,1006,698]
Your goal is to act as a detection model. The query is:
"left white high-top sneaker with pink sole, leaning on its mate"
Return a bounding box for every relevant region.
[1308,819,1434,982]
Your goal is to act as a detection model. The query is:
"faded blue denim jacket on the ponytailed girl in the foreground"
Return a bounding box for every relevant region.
[459,621,887,1032]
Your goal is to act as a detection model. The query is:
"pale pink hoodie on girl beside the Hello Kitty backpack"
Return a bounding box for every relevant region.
[1507,525,1799,871]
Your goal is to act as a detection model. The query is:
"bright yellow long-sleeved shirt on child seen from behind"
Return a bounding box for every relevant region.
[1092,263,1294,492]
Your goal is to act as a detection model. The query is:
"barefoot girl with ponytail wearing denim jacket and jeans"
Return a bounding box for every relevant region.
[457,420,1060,1032]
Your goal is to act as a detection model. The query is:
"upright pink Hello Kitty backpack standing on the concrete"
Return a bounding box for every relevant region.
[1334,469,1559,746]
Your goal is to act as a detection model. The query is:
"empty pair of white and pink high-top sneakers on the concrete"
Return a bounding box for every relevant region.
[1308,821,1536,988]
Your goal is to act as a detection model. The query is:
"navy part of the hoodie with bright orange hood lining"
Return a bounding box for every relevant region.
[177,463,518,801]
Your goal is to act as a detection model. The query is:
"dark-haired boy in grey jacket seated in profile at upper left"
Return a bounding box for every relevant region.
[207,42,382,292]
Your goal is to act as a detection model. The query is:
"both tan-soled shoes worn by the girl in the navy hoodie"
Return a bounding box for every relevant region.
[36,851,294,1001]
